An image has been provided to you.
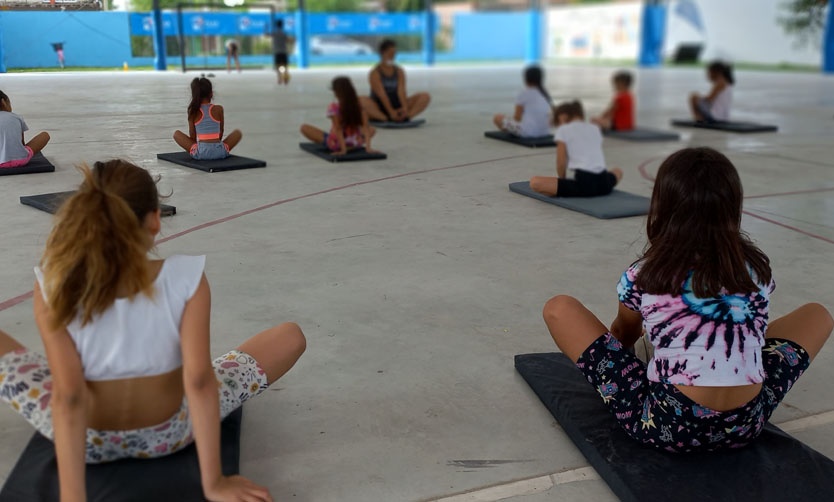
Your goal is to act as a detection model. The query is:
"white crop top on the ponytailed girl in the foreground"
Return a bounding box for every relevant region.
[35,255,206,381]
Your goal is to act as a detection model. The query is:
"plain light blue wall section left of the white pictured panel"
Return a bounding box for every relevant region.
[452,12,530,60]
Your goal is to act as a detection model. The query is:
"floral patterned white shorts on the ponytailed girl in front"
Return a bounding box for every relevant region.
[0,349,269,464]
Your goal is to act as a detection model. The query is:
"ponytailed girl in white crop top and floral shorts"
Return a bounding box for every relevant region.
[0,160,305,501]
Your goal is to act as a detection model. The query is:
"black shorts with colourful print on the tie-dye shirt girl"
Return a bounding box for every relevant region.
[576,333,811,453]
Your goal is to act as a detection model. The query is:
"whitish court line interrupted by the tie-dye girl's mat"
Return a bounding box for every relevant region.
[431,410,834,502]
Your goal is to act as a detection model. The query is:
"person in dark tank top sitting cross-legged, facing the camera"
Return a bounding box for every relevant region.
[359,40,431,122]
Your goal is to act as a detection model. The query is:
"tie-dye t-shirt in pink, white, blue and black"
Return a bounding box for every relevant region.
[617,262,775,387]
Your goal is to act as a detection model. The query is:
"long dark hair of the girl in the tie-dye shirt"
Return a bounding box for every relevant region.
[637,147,771,298]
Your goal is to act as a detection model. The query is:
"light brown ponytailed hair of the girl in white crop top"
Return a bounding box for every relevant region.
[41,160,159,328]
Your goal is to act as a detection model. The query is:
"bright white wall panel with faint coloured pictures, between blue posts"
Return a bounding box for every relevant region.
[546,1,642,59]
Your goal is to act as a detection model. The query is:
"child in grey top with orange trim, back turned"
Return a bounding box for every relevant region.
[174,77,243,160]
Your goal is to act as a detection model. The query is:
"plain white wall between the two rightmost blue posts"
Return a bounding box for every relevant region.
[664,0,822,65]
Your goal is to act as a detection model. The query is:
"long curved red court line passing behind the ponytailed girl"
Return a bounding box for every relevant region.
[0,151,553,312]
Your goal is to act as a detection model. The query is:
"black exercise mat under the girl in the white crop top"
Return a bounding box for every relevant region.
[0,408,243,502]
